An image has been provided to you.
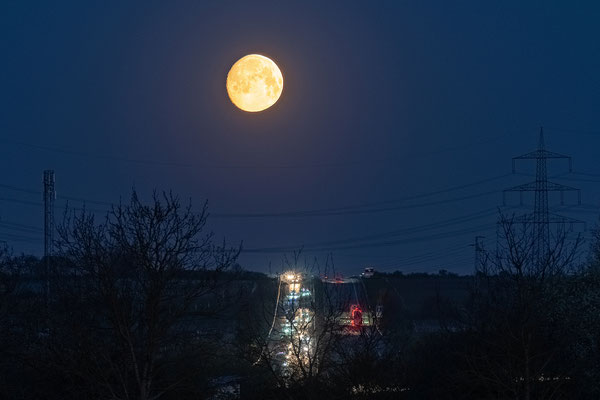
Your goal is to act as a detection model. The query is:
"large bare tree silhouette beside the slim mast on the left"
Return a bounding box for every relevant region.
[54,191,239,400]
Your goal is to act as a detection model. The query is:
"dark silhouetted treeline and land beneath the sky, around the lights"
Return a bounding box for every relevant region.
[0,193,600,400]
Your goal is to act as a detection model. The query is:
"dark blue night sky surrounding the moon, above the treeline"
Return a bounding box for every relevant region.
[0,1,600,274]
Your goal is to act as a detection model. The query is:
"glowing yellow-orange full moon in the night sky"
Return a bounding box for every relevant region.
[227,54,283,112]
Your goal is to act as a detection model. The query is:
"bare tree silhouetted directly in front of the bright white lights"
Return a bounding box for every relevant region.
[236,251,348,399]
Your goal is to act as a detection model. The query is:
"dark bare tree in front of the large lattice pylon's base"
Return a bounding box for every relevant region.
[461,216,581,400]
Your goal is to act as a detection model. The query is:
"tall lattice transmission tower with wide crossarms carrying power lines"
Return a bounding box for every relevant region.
[503,128,583,263]
